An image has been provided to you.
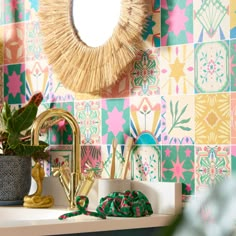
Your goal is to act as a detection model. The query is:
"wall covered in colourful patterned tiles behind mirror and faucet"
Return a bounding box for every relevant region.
[0,0,236,203]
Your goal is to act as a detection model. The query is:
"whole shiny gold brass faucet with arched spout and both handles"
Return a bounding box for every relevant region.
[26,108,95,209]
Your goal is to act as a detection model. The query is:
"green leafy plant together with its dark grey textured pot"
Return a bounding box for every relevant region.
[0,93,48,205]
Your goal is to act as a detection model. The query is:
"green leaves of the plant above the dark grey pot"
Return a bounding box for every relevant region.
[0,93,48,160]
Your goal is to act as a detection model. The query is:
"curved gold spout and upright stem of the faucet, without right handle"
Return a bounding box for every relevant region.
[31,108,81,208]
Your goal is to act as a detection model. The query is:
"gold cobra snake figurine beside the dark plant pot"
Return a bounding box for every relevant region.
[23,162,54,208]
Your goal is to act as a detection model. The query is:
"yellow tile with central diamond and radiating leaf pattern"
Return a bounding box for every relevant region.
[195,93,230,144]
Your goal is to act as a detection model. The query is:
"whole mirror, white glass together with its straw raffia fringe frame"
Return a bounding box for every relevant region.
[39,0,148,93]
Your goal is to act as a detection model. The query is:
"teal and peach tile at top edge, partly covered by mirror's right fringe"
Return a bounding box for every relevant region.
[142,0,161,47]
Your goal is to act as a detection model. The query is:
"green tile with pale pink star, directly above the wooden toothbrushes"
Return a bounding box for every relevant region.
[102,99,130,144]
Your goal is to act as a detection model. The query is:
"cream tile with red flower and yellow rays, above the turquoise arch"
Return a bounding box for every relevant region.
[130,96,161,143]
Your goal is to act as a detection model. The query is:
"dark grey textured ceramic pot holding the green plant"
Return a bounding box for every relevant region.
[0,155,31,205]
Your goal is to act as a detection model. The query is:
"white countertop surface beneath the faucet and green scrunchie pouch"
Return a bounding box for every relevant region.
[0,206,173,236]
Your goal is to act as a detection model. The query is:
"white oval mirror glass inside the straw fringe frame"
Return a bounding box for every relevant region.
[72,0,121,47]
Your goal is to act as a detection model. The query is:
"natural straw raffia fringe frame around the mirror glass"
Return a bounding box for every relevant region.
[39,0,148,93]
